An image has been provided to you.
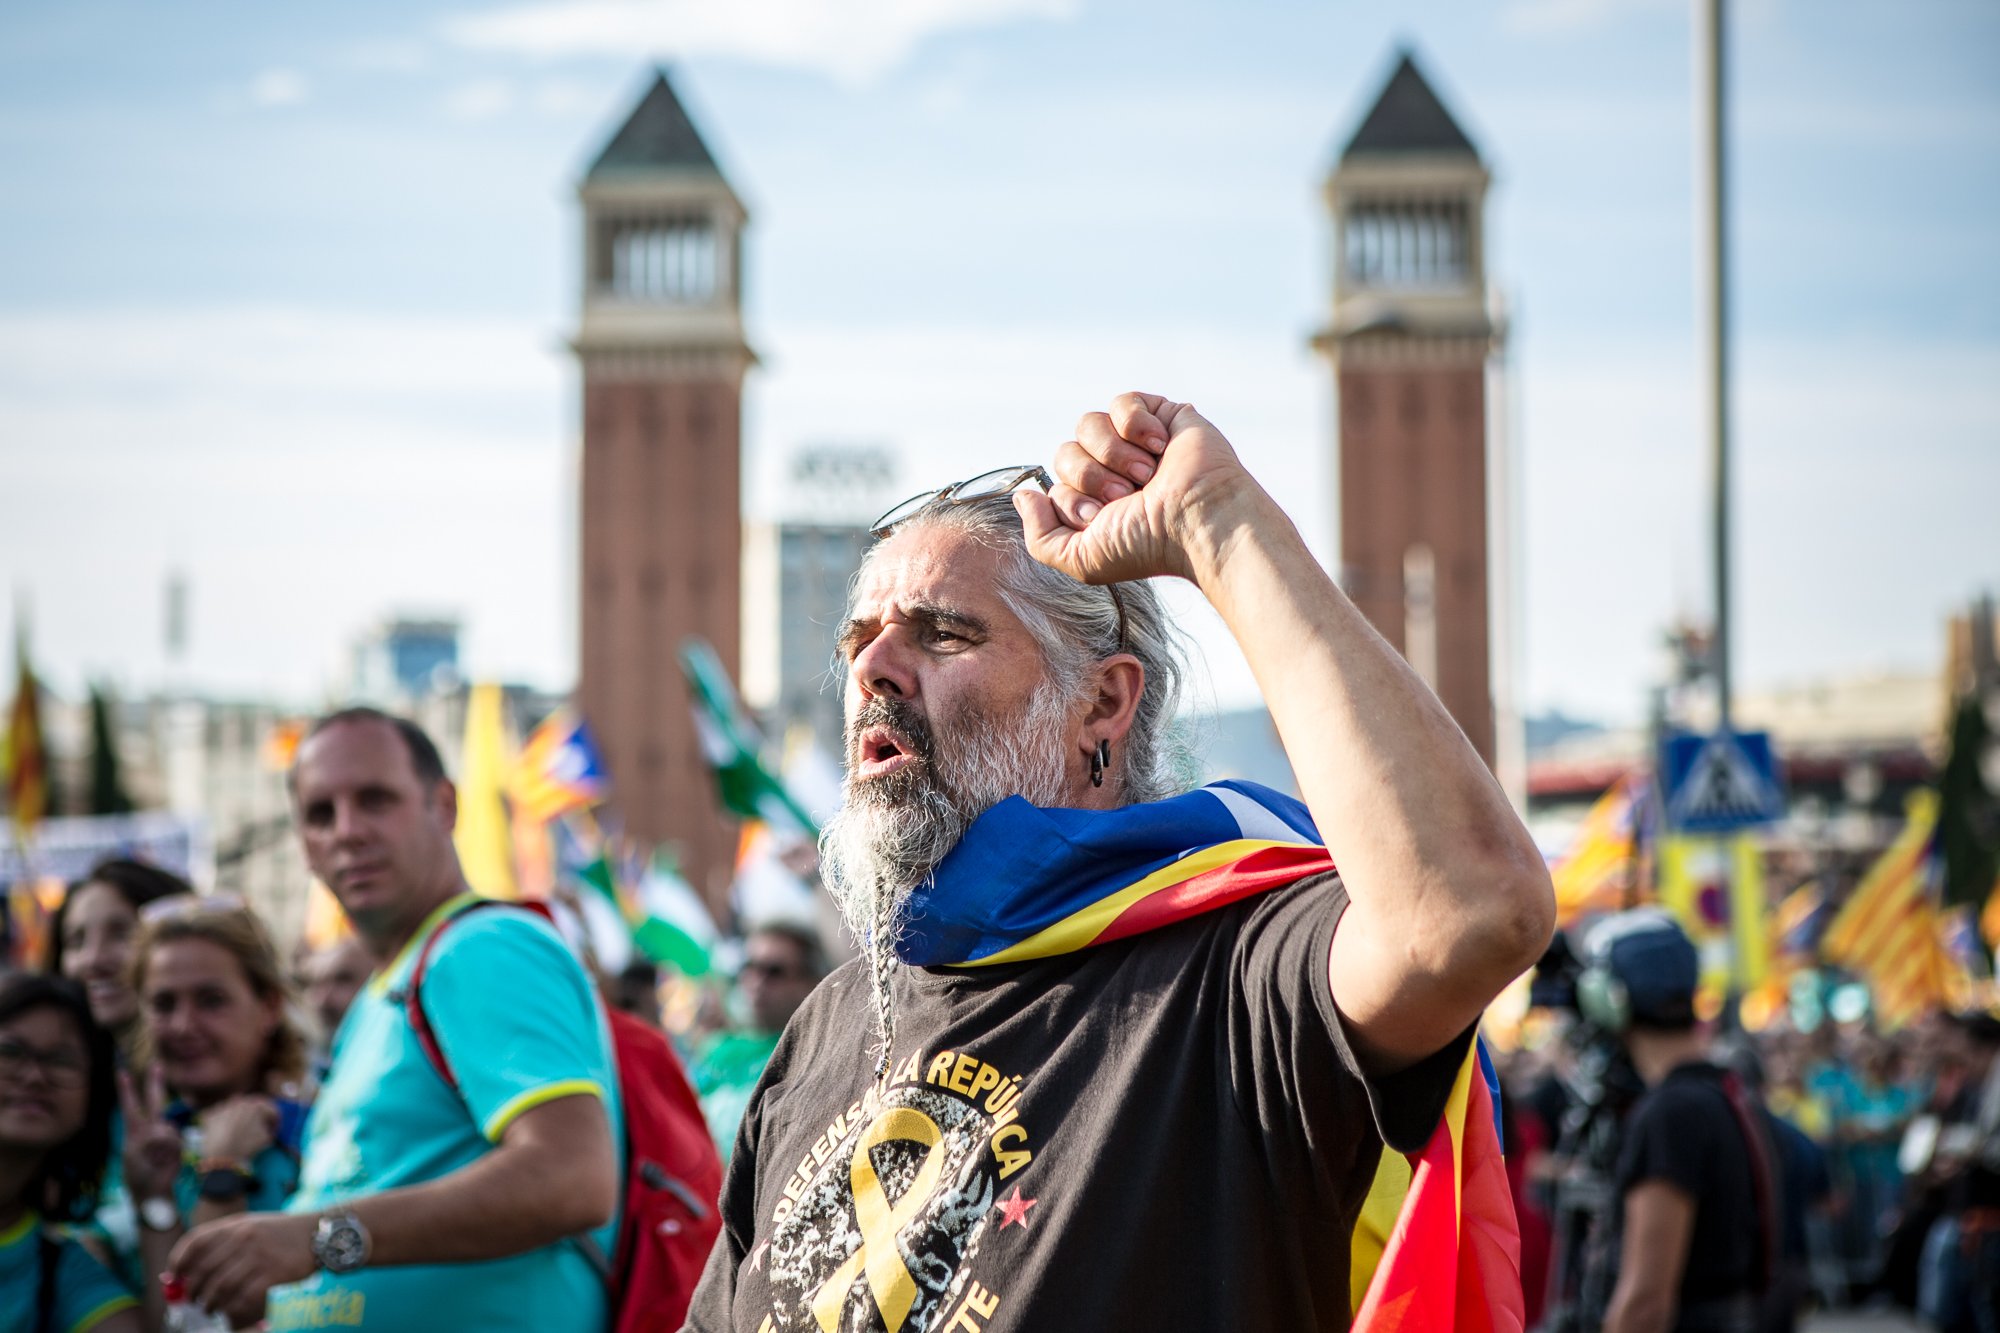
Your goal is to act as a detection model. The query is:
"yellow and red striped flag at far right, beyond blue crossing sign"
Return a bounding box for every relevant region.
[1820,791,1964,1027]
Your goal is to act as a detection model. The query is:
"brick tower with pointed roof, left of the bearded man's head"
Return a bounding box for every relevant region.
[574,72,756,905]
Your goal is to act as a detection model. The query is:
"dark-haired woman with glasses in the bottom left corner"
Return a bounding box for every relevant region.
[0,973,142,1333]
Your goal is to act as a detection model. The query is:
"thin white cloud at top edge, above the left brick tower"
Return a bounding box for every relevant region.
[444,0,1074,80]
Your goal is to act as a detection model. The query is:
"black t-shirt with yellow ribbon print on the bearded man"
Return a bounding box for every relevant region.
[688,877,1470,1333]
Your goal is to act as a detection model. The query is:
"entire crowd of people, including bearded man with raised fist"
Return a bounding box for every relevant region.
[0,394,1968,1333]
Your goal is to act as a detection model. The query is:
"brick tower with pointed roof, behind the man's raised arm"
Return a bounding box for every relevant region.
[1314,54,1500,765]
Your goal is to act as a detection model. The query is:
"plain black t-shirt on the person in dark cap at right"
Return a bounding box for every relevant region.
[1612,1061,1776,1309]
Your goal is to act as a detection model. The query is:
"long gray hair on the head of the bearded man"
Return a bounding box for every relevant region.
[850,494,1192,805]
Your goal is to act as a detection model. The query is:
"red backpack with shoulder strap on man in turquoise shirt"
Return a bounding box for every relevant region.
[404,899,722,1333]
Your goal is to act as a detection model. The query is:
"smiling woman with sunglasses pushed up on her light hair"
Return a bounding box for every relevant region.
[101,895,306,1307]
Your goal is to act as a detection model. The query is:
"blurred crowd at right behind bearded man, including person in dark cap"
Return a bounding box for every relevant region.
[1502,913,2000,1333]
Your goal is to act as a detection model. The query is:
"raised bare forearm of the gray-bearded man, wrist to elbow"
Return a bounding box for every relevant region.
[1186,484,1554,1045]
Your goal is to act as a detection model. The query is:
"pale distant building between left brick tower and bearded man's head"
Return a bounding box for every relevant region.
[744,444,902,755]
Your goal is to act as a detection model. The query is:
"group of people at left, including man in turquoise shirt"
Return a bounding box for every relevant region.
[0,709,826,1333]
